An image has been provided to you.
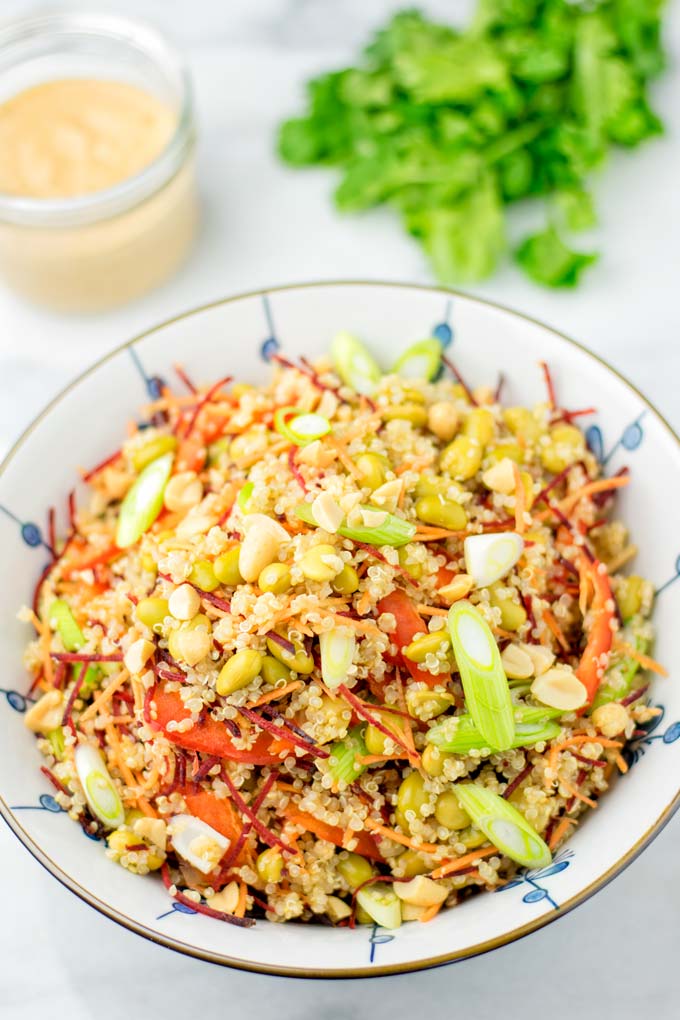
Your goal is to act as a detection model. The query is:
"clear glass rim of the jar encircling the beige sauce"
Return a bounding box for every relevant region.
[0,10,195,227]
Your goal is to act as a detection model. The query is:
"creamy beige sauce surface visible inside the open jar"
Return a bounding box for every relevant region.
[0,79,176,198]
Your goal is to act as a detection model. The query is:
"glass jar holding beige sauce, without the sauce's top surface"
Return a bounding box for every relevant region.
[0,11,198,311]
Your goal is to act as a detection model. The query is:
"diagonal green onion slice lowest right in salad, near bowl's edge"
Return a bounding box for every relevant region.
[454,782,553,868]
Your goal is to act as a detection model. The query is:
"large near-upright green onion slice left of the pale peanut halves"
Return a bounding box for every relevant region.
[449,601,515,751]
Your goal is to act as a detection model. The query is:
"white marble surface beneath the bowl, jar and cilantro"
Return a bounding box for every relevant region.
[0,0,680,1020]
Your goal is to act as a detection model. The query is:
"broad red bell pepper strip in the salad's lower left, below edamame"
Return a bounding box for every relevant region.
[151,684,279,765]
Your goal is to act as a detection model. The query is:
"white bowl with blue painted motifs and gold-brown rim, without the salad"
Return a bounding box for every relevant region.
[0,283,680,977]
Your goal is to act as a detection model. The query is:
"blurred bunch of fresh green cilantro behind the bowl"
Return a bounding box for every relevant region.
[278,0,664,287]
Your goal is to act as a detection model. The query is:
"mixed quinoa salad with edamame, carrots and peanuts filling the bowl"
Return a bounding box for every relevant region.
[20,333,663,928]
